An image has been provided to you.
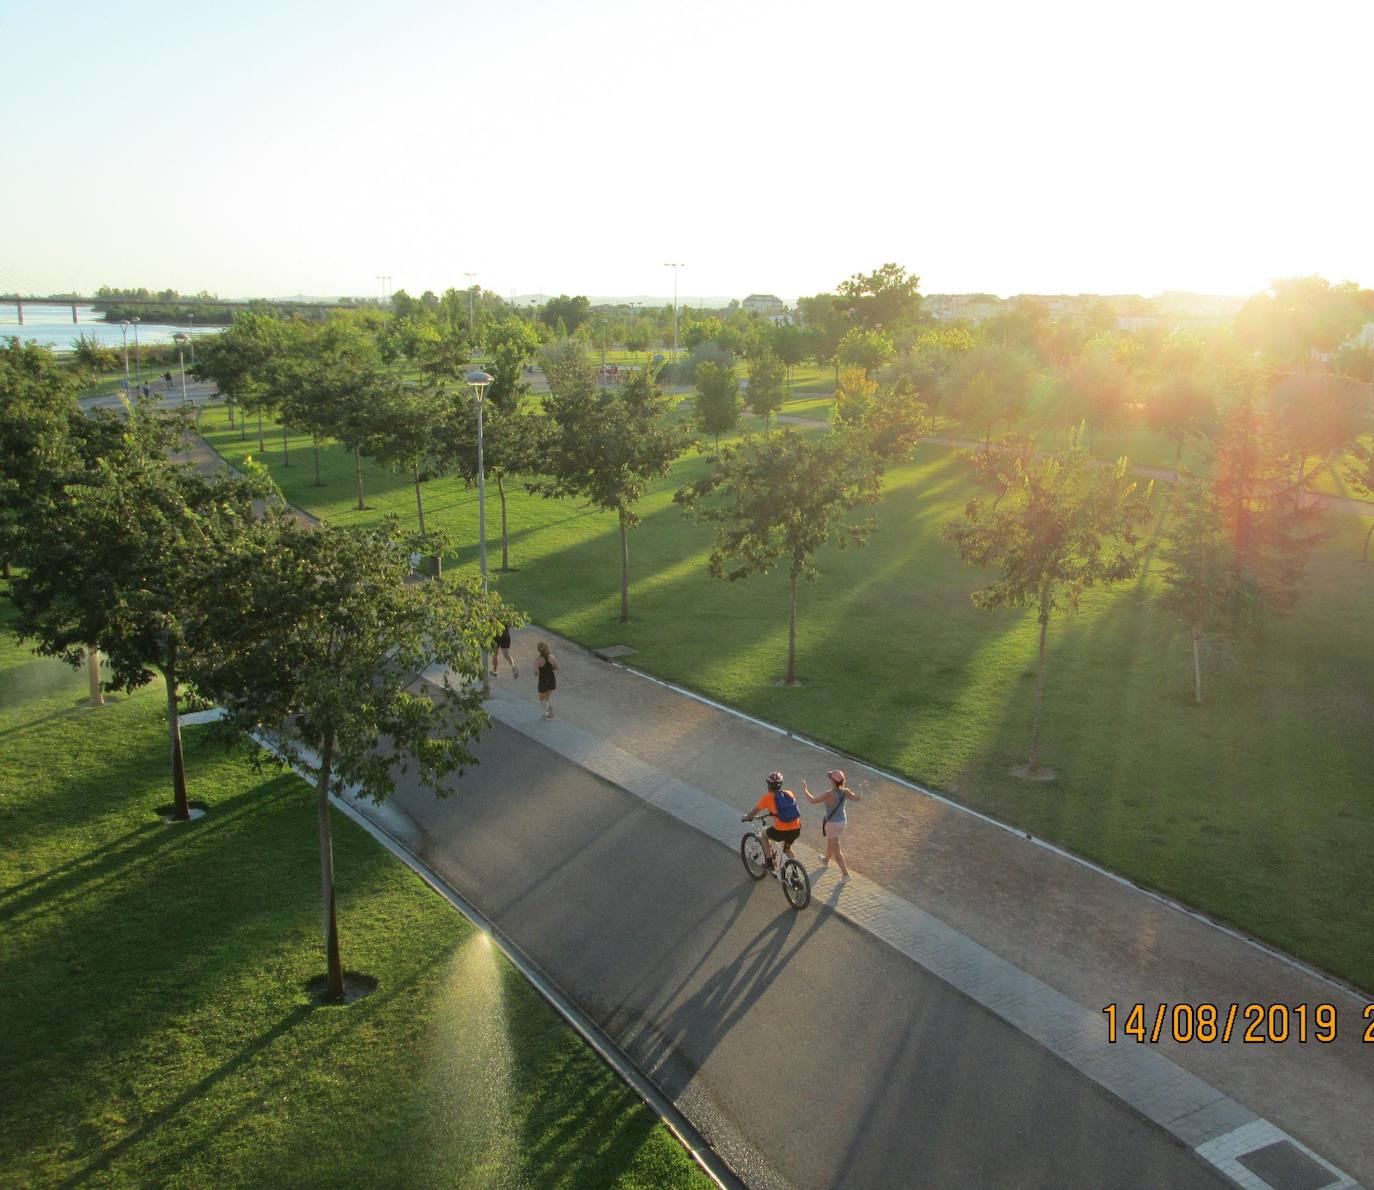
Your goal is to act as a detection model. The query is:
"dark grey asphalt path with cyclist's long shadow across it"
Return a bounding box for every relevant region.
[373,724,1227,1187]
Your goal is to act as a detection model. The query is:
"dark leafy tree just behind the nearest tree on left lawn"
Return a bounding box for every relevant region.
[11,403,262,820]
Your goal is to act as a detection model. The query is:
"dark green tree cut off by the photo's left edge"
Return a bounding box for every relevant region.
[0,337,80,579]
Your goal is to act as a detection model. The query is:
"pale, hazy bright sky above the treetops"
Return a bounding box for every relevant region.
[0,0,1374,301]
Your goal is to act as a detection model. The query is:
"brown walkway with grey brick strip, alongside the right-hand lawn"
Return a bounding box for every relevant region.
[442,628,1374,1187]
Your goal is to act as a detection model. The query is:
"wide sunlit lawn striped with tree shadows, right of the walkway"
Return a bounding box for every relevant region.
[199,411,1374,988]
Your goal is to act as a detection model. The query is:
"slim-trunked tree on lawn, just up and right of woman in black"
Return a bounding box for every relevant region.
[526,353,687,624]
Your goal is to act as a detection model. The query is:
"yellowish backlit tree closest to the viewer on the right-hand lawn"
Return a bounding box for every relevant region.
[944,434,1150,775]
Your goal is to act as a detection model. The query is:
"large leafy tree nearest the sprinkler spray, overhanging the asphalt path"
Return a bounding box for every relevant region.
[194,515,519,1002]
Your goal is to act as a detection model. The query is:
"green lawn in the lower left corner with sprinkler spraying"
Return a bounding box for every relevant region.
[0,603,709,1187]
